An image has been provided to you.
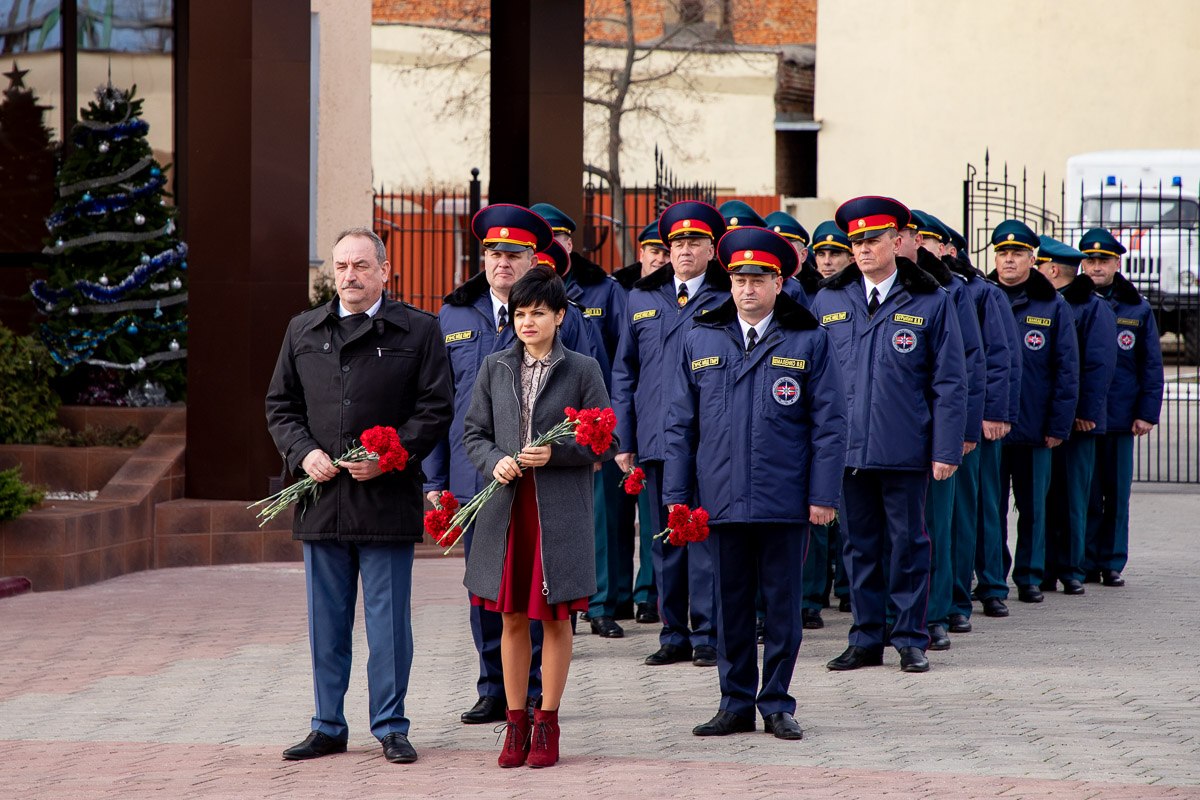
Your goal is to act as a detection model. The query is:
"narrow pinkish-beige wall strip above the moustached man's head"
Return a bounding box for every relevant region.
[312,0,373,277]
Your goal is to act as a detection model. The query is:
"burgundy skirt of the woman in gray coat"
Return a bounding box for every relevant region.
[470,469,588,620]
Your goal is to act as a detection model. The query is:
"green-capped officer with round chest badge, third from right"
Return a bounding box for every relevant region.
[990,219,1079,603]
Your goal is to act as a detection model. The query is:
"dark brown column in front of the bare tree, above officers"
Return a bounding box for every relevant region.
[488,0,583,221]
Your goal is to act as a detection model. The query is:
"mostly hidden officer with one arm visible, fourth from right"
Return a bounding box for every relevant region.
[935,224,1021,633]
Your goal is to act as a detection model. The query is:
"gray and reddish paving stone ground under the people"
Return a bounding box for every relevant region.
[0,489,1200,800]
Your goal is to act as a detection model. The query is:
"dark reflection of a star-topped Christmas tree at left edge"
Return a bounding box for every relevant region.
[0,61,54,253]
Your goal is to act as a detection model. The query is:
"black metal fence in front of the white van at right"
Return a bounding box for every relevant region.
[962,155,1200,483]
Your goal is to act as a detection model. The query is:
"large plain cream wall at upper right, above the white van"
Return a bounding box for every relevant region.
[815,0,1200,237]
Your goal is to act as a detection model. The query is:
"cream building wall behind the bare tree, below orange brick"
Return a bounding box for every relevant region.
[371,25,776,194]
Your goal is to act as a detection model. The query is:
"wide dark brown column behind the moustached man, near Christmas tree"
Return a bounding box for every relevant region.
[176,0,312,499]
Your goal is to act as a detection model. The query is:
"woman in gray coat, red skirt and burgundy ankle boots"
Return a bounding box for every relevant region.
[463,267,617,766]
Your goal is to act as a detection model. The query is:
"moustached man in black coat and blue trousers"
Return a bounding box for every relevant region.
[266,228,454,764]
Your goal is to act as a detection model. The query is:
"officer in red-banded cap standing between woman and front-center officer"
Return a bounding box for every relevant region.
[612,200,724,667]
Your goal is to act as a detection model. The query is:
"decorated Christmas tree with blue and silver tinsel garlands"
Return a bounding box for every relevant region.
[30,84,187,405]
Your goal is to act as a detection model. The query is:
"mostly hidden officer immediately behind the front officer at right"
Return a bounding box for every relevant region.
[900,210,986,650]
